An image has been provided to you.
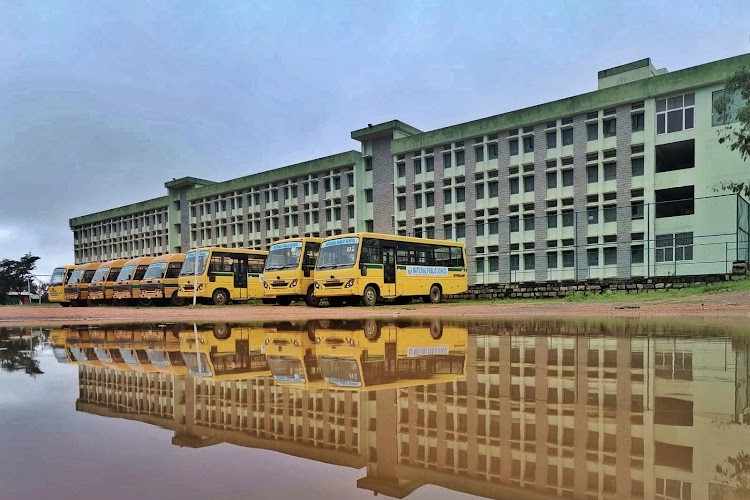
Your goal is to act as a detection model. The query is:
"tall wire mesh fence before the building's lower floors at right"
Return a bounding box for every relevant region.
[410,194,750,284]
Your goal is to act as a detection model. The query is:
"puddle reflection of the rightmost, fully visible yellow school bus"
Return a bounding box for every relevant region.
[315,321,468,389]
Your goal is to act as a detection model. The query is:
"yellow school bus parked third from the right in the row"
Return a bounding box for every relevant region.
[178,247,268,305]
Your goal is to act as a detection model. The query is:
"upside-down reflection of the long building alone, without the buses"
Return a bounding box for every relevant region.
[67,322,750,499]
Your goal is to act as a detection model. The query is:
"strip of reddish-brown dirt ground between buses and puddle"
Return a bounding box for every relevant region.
[0,291,750,327]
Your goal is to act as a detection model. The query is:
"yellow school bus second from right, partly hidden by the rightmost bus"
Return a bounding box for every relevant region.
[263,237,323,306]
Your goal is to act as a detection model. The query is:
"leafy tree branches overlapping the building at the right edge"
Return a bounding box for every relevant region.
[714,68,750,197]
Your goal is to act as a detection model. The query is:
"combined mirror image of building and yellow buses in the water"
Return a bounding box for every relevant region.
[50,321,750,498]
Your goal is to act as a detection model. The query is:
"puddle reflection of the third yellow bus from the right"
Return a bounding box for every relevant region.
[180,324,271,380]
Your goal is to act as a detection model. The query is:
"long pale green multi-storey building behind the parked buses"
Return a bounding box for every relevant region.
[70,55,750,283]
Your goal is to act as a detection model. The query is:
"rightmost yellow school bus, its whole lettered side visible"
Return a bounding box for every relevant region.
[315,233,469,306]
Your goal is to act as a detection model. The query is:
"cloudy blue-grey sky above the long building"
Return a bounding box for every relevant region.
[0,0,750,274]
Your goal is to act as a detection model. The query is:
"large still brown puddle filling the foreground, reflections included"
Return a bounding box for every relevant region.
[0,320,750,500]
